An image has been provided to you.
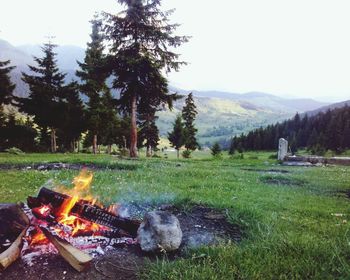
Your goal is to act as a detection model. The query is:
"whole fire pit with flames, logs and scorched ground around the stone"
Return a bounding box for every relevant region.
[0,170,241,280]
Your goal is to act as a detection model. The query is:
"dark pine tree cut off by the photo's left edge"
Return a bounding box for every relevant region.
[0,60,16,106]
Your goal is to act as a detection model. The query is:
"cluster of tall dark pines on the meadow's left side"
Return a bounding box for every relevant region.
[0,0,193,157]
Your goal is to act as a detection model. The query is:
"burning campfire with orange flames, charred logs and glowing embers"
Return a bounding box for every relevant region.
[0,170,141,271]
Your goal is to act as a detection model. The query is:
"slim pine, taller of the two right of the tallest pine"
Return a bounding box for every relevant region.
[182,92,198,151]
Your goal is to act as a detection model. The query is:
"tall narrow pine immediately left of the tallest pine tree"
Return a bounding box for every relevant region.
[76,16,110,154]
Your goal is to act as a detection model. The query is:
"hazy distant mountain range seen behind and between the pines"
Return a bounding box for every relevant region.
[0,39,329,145]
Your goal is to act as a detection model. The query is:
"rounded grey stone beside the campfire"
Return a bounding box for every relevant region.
[137,211,182,252]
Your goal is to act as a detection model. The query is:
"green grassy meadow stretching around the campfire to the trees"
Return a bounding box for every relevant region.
[0,152,350,280]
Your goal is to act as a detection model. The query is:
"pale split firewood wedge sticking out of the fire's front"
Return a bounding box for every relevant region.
[40,227,92,272]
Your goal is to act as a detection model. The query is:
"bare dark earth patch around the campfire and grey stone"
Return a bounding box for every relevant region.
[0,204,242,280]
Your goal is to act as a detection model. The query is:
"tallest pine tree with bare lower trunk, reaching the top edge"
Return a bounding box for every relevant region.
[105,0,188,157]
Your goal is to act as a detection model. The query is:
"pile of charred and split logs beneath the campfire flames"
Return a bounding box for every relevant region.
[0,187,140,272]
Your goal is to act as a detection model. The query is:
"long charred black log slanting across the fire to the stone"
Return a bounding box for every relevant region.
[28,187,141,237]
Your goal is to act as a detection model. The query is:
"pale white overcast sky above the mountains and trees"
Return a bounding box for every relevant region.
[0,0,350,101]
